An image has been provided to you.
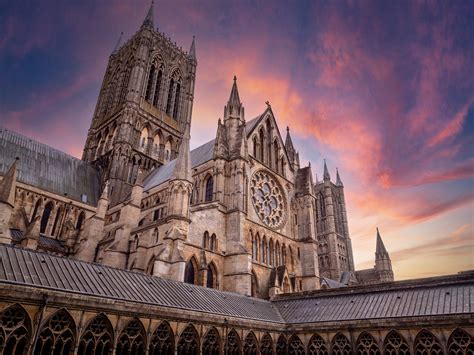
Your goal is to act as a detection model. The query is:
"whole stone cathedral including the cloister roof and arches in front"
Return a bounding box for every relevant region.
[0,4,474,354]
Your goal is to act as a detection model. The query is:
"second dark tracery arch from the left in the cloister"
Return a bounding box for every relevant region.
[33,309,76,355]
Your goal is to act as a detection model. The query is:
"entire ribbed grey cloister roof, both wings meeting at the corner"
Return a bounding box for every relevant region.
[0,244,474,324]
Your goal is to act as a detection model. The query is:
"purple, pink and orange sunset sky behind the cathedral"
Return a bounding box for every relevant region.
[0,0,474,280]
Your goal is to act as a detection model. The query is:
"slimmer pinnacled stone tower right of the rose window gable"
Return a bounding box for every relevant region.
[315,162,355,283]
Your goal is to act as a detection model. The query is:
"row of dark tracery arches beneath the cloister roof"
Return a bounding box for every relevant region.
[0,303,474,355]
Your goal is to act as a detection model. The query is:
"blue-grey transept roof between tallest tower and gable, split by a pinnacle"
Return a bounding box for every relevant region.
[143,139,214,191]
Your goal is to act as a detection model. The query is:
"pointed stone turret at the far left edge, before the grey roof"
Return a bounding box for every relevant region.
[0,160,17,244]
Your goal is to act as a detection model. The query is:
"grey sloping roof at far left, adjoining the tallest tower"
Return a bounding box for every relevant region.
[0,127,100,205]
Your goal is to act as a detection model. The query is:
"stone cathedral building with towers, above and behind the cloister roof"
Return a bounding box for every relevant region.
[0,0,393,299]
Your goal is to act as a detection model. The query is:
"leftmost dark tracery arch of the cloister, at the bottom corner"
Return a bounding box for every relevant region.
[0,304,31,355]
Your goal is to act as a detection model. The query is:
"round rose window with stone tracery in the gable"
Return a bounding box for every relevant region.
[250,171,285,228]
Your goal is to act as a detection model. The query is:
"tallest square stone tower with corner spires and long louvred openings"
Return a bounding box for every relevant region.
[82,4,197,206]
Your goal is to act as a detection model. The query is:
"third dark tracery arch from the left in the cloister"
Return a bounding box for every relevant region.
[78,314,114,355]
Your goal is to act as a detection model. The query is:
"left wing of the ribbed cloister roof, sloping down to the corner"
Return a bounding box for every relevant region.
[0,244,282,323]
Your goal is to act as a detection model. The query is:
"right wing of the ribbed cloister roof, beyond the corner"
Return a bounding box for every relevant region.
[273,276,474,323]
